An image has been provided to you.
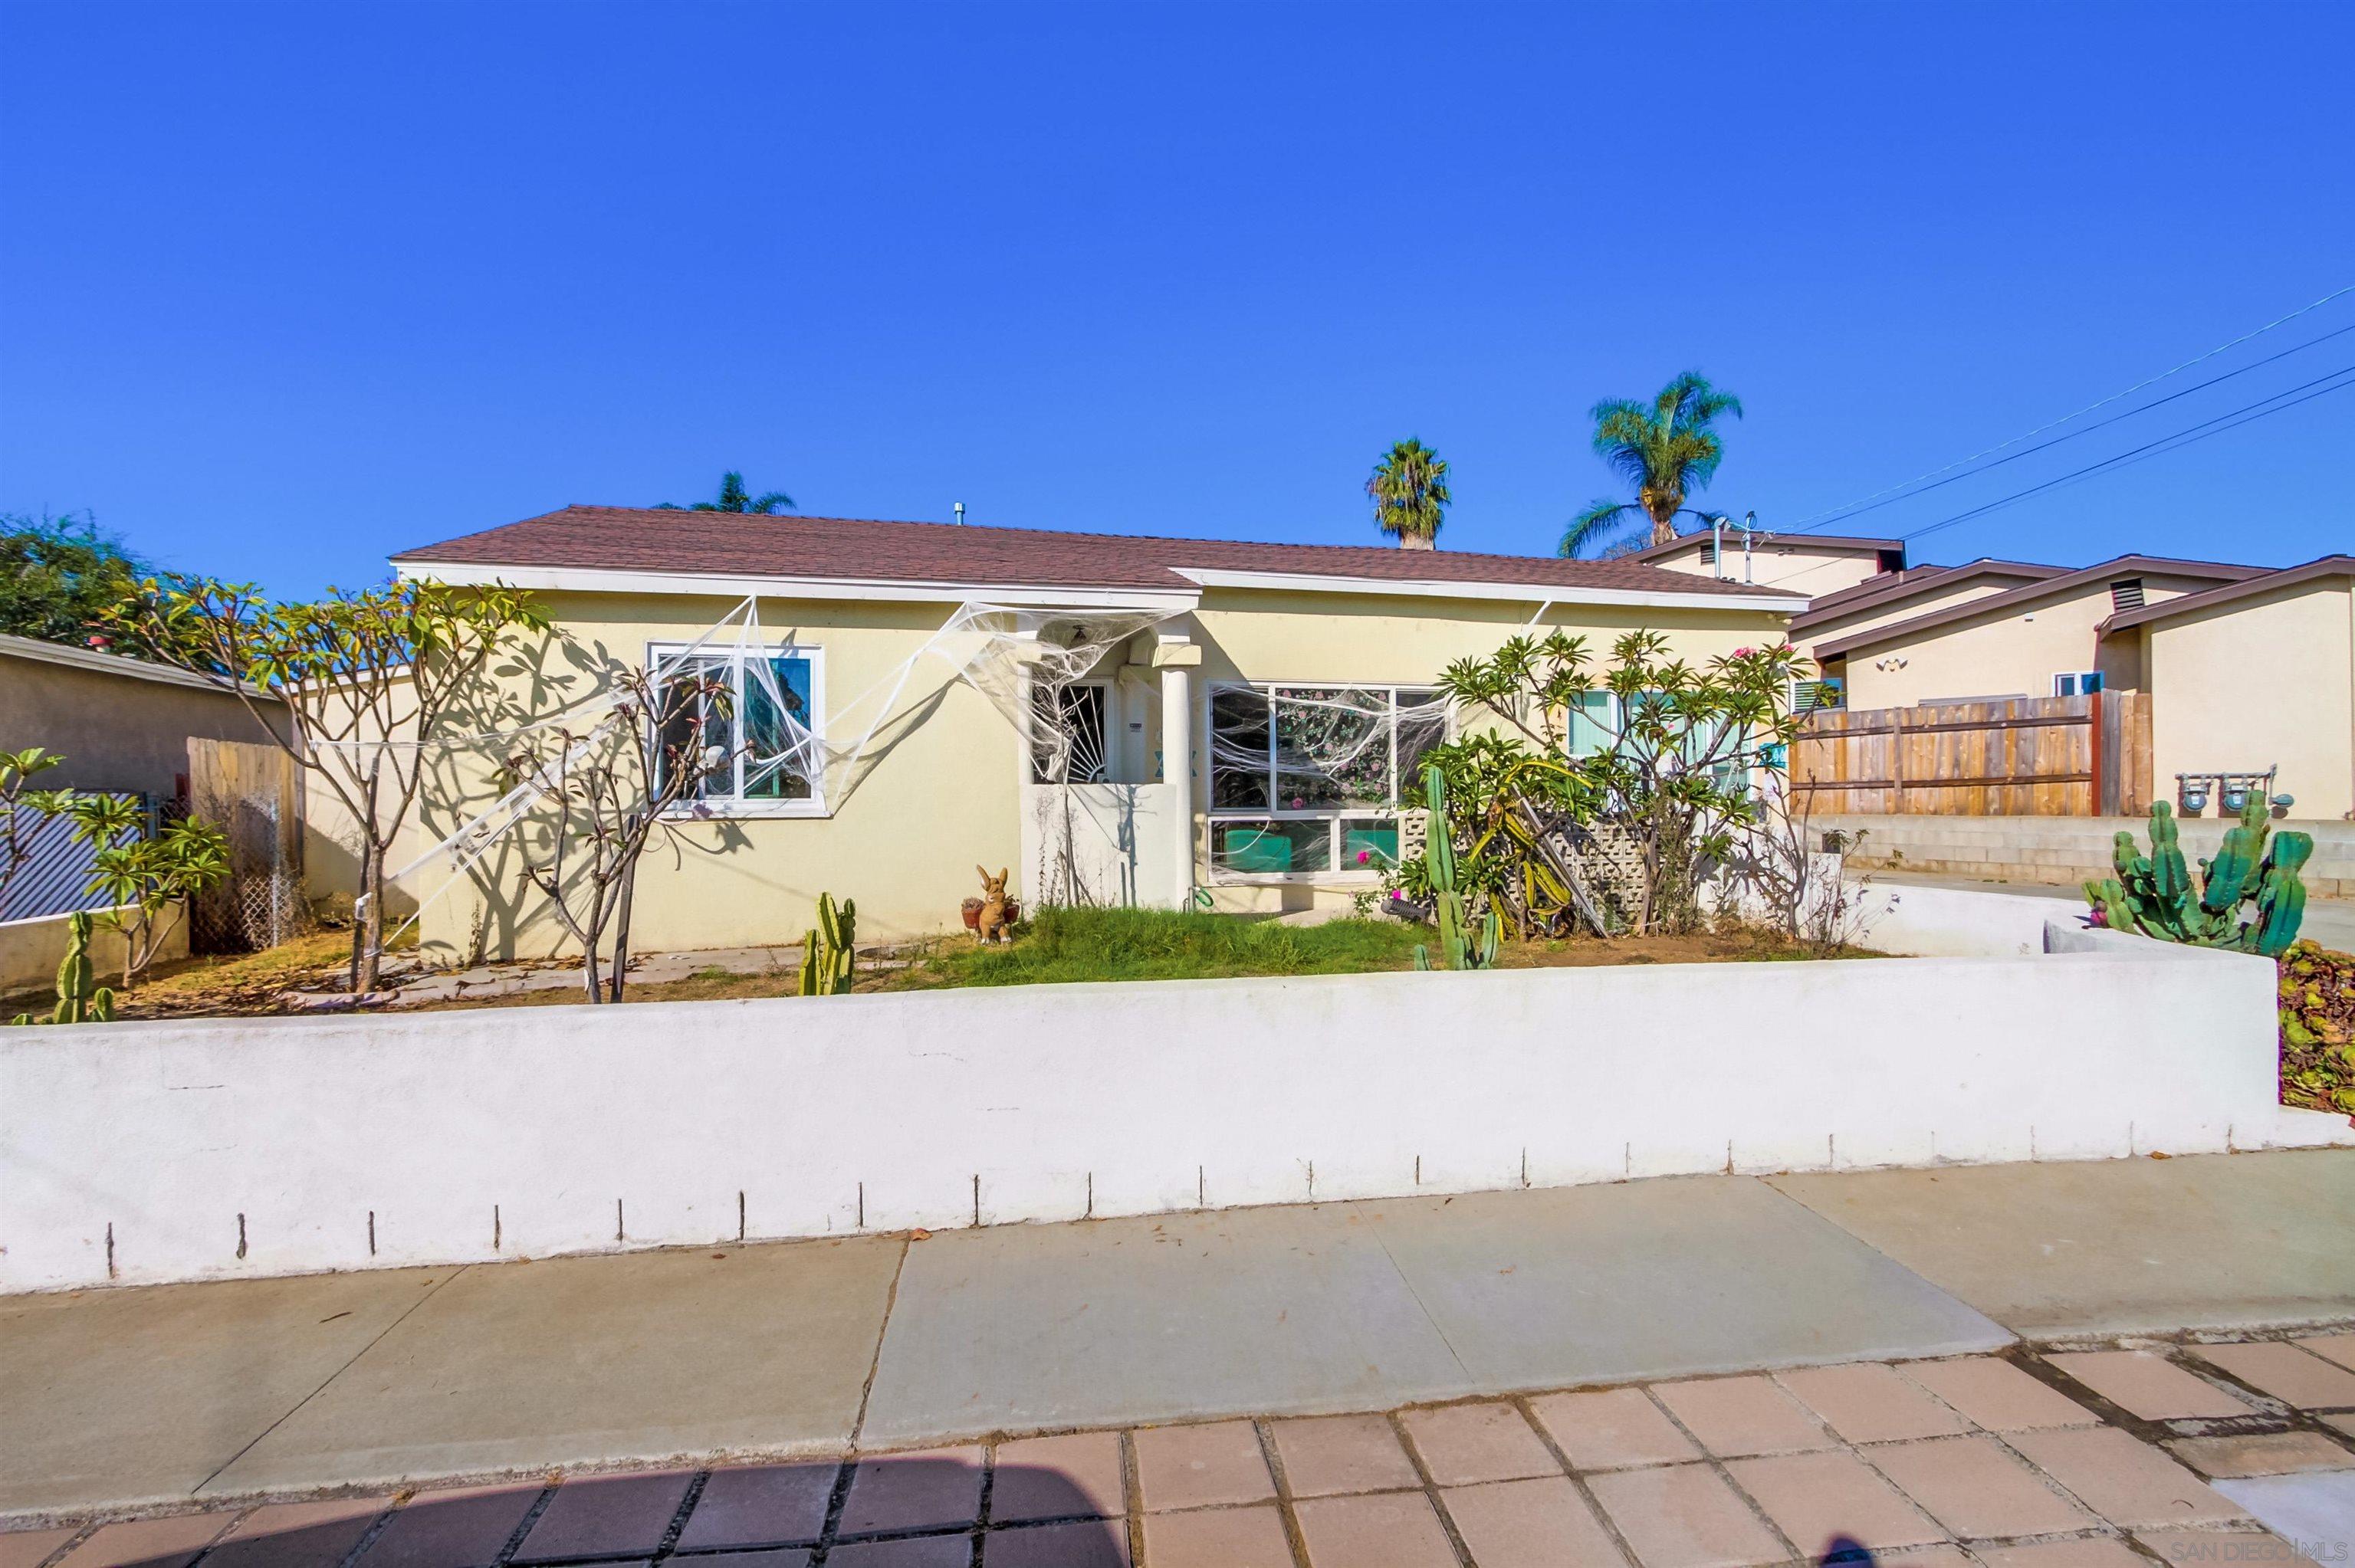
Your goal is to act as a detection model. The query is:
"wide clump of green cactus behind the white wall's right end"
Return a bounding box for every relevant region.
[2084,795,2315,958]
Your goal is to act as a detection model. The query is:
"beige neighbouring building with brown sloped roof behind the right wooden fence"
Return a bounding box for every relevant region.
[1792,556,2261,709]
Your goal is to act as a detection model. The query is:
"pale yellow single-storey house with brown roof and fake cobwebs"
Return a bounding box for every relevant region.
[393,506,1806,956]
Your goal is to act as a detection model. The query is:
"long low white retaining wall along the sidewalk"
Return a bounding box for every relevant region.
[0,908,2322,1290]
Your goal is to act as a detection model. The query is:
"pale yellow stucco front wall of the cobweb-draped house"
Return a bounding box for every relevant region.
[417,591,1785,958]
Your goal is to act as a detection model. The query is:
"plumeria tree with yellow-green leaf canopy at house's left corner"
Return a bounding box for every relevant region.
[106,577,549,996]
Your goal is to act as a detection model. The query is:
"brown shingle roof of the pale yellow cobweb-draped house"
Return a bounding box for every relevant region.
[393,506,1804,605]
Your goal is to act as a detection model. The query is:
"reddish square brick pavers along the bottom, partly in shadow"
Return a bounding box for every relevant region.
[0,1333,2355,1568]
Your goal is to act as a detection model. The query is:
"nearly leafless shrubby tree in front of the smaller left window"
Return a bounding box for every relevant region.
[506,668,734,1003]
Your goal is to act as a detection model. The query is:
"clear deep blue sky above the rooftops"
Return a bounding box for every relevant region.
[0,0,2355,593]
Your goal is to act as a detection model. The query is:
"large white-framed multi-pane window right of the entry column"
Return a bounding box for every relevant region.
[1210,685,1448,878]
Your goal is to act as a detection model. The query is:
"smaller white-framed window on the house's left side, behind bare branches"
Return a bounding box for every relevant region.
[648,645,826,817]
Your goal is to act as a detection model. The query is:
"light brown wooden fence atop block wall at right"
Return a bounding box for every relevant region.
[1790,692,2150,817]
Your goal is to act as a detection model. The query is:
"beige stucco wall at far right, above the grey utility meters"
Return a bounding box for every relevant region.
[2143,577,2355,822]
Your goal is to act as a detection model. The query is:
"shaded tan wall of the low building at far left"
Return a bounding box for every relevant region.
[0,650,286,798]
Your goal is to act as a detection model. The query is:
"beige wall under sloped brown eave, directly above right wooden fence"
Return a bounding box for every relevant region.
[1846,572,2214,709]
